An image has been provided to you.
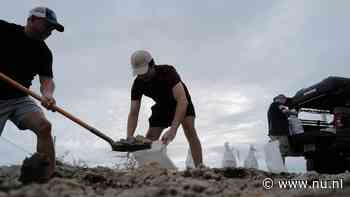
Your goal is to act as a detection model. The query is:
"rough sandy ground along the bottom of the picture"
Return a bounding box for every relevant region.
[0,163,350,197]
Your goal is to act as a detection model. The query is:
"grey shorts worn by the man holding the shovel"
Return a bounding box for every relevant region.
[0,97,43,135]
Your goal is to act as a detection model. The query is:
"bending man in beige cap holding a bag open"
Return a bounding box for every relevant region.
[127,51,203,166]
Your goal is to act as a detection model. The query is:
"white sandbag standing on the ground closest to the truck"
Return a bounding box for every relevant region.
[264,140,287,173]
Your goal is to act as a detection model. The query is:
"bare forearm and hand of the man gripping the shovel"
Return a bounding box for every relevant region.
[39,76,56,109]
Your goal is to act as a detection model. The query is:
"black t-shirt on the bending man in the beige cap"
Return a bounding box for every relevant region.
[131,65,191,106]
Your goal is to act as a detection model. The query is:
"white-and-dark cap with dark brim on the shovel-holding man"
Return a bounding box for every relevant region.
[29,7,64,32]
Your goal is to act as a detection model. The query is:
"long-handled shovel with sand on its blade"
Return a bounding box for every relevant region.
[0,72,151,152]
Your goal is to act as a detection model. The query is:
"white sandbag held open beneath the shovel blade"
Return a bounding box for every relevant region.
[132,141,176,169]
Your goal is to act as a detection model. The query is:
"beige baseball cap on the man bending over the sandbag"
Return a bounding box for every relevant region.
[131,50,153,76]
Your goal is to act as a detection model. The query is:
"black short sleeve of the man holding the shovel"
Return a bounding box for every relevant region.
[38,45,53,78]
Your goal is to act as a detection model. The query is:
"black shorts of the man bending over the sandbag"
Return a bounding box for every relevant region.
[148,102,196,128]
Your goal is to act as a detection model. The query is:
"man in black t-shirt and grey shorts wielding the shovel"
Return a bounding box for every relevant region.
[0,7,64,178]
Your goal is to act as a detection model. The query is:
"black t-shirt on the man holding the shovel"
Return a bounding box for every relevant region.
[0,20,53,100]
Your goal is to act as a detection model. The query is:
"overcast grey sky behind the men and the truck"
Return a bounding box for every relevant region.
[0,0,350,170]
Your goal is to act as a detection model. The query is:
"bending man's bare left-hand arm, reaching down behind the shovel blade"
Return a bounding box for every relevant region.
[126,100,141,137]
